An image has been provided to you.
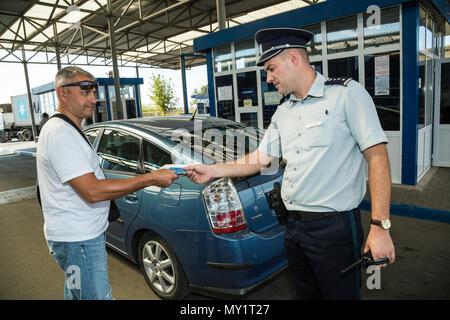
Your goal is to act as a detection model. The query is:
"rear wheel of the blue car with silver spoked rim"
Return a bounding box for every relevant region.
[138,232,190,300]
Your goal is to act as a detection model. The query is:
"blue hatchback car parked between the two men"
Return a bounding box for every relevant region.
[85,115,287,299]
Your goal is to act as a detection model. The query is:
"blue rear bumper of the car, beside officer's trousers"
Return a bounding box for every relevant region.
[180,225,287,295]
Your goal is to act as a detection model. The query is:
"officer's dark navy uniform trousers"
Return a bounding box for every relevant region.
[284,209,364,300]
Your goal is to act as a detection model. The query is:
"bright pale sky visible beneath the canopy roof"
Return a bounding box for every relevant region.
[0,62,208,108]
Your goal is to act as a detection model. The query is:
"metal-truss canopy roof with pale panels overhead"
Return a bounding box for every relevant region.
[0,0,324,69]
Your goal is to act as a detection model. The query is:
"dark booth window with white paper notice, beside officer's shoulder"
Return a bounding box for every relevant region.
[364,51,400,131]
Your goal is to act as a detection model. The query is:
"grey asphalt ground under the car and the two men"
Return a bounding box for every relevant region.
[0,141,450,300]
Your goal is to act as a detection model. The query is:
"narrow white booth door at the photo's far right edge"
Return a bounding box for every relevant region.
[433,58,450,167]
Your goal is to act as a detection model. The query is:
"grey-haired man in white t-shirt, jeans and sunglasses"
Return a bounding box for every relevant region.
[37,67,177,300]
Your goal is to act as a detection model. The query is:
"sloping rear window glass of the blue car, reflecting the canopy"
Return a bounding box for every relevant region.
[170,124,264,163]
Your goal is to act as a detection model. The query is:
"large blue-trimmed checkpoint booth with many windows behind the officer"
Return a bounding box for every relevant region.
[194,0,450,185]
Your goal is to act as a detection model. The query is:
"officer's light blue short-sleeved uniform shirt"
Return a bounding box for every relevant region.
[258,73,388,212]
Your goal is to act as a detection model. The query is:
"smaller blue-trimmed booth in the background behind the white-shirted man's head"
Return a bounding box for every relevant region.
[31,78,144,123]
